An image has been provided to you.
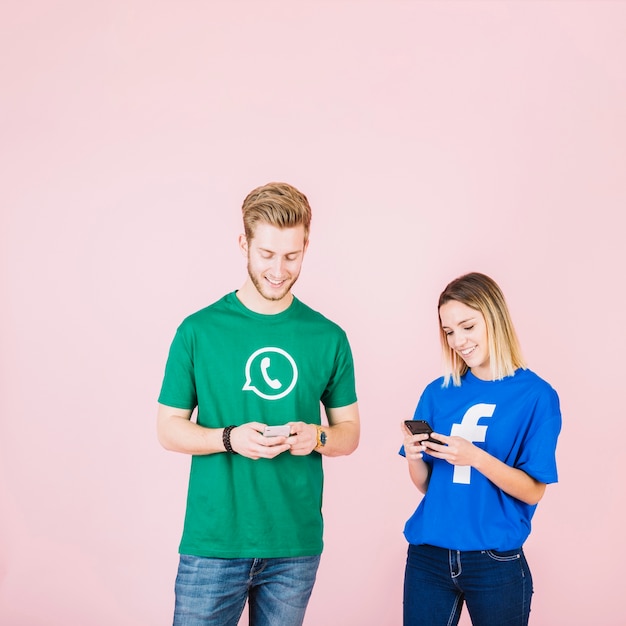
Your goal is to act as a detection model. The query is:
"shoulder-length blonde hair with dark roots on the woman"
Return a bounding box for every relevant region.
[437,272,526,387]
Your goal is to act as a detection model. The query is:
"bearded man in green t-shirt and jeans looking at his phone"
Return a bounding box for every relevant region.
[157,183,360,626]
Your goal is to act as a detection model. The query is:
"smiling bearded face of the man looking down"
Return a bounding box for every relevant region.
[239,223,308,302]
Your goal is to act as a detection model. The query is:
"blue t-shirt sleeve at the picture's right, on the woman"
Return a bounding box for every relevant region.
[515,386,561,483]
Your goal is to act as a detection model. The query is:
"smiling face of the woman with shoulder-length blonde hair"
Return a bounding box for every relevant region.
[439,300,492,380]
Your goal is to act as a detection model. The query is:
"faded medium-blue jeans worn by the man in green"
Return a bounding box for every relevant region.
[174,554,320,626]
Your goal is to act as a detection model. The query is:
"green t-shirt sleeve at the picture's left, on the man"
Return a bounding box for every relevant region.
[159,326,198,410]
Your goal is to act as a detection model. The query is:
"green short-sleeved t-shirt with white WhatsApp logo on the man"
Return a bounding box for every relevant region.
[159,292,356,558]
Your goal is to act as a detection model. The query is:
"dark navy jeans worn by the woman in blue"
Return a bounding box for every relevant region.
[404,545,533,626]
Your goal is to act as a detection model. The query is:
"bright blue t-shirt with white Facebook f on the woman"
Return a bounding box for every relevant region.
[401,369,561,550]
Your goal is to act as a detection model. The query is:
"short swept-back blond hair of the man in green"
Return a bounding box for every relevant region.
[241,183,311,242]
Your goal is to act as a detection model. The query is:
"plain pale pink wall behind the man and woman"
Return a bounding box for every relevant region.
[0,0,626,626]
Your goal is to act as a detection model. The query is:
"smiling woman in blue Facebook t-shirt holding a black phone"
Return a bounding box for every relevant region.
[401,273,561,626]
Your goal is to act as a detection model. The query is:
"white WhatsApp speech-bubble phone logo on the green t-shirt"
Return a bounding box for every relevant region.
[243,348,298,400]
